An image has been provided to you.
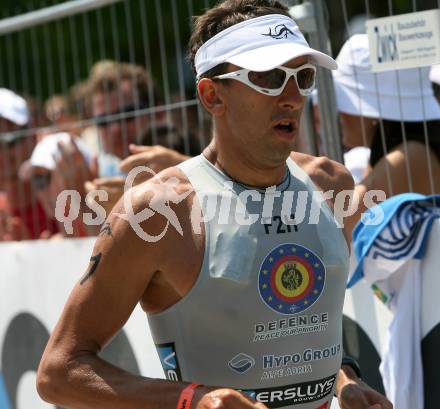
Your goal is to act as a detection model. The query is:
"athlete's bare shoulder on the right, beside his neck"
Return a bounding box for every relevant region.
[290,152,354,193]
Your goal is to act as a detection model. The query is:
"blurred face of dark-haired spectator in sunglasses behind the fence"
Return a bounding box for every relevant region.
[92,80,150,159]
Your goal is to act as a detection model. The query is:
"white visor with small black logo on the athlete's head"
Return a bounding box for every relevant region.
[195,14,337,78]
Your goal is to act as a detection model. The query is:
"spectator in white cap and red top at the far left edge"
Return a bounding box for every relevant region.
[0,88,56,241]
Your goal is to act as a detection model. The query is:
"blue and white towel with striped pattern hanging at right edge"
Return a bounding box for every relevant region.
[348,193,440,409]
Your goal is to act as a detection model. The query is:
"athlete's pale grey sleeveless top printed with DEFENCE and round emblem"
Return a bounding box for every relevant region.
[148,155,349,409]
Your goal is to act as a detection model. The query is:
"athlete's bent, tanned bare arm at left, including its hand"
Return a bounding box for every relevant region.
[37,171,264,409]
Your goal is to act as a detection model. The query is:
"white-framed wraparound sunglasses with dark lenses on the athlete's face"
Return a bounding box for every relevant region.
[213,64,316,96]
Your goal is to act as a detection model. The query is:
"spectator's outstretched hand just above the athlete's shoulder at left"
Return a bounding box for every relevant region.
[119,145,189,176]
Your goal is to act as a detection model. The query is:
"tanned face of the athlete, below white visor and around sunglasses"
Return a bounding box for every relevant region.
[217,56,307,166]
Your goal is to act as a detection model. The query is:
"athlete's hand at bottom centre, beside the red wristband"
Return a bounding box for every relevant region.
[191,388,268,409]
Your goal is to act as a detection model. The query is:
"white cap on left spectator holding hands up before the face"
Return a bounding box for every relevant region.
[29,132,92,170]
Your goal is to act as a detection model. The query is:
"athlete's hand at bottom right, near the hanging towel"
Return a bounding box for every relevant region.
[336,365,393,409]
